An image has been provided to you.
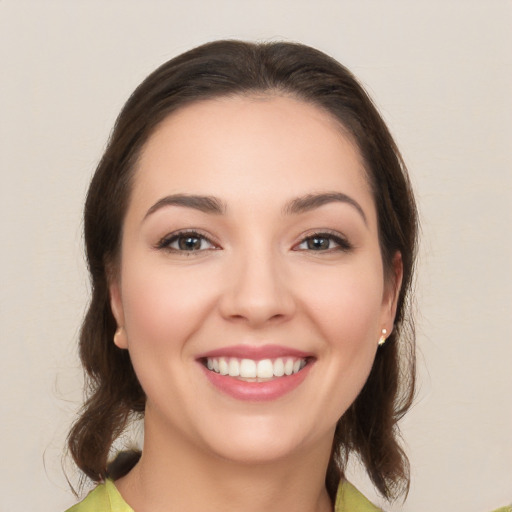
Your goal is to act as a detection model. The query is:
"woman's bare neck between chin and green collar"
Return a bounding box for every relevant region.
[116,414,333,512]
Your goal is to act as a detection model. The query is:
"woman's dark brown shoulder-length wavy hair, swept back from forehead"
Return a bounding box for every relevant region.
[68,41,417,499]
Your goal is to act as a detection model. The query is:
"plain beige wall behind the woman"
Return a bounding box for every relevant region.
[0,0,512,512]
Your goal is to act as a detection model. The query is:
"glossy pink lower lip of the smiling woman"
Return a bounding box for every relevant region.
[201,363,312,402]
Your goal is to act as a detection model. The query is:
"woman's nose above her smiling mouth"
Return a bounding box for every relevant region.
[219,246,296,328]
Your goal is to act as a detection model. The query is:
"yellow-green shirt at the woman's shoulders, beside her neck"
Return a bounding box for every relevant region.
[67,480,380,512]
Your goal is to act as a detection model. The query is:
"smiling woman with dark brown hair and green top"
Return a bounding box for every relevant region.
[69,41,416,512]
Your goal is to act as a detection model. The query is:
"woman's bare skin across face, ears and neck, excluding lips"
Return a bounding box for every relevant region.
[110,96,401,512]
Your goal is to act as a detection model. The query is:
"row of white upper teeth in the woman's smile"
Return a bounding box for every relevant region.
[206,357,306,379]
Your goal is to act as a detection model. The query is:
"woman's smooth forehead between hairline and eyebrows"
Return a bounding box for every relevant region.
[132,95,370,215]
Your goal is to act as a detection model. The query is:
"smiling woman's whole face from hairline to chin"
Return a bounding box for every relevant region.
[111,96,400,461]
